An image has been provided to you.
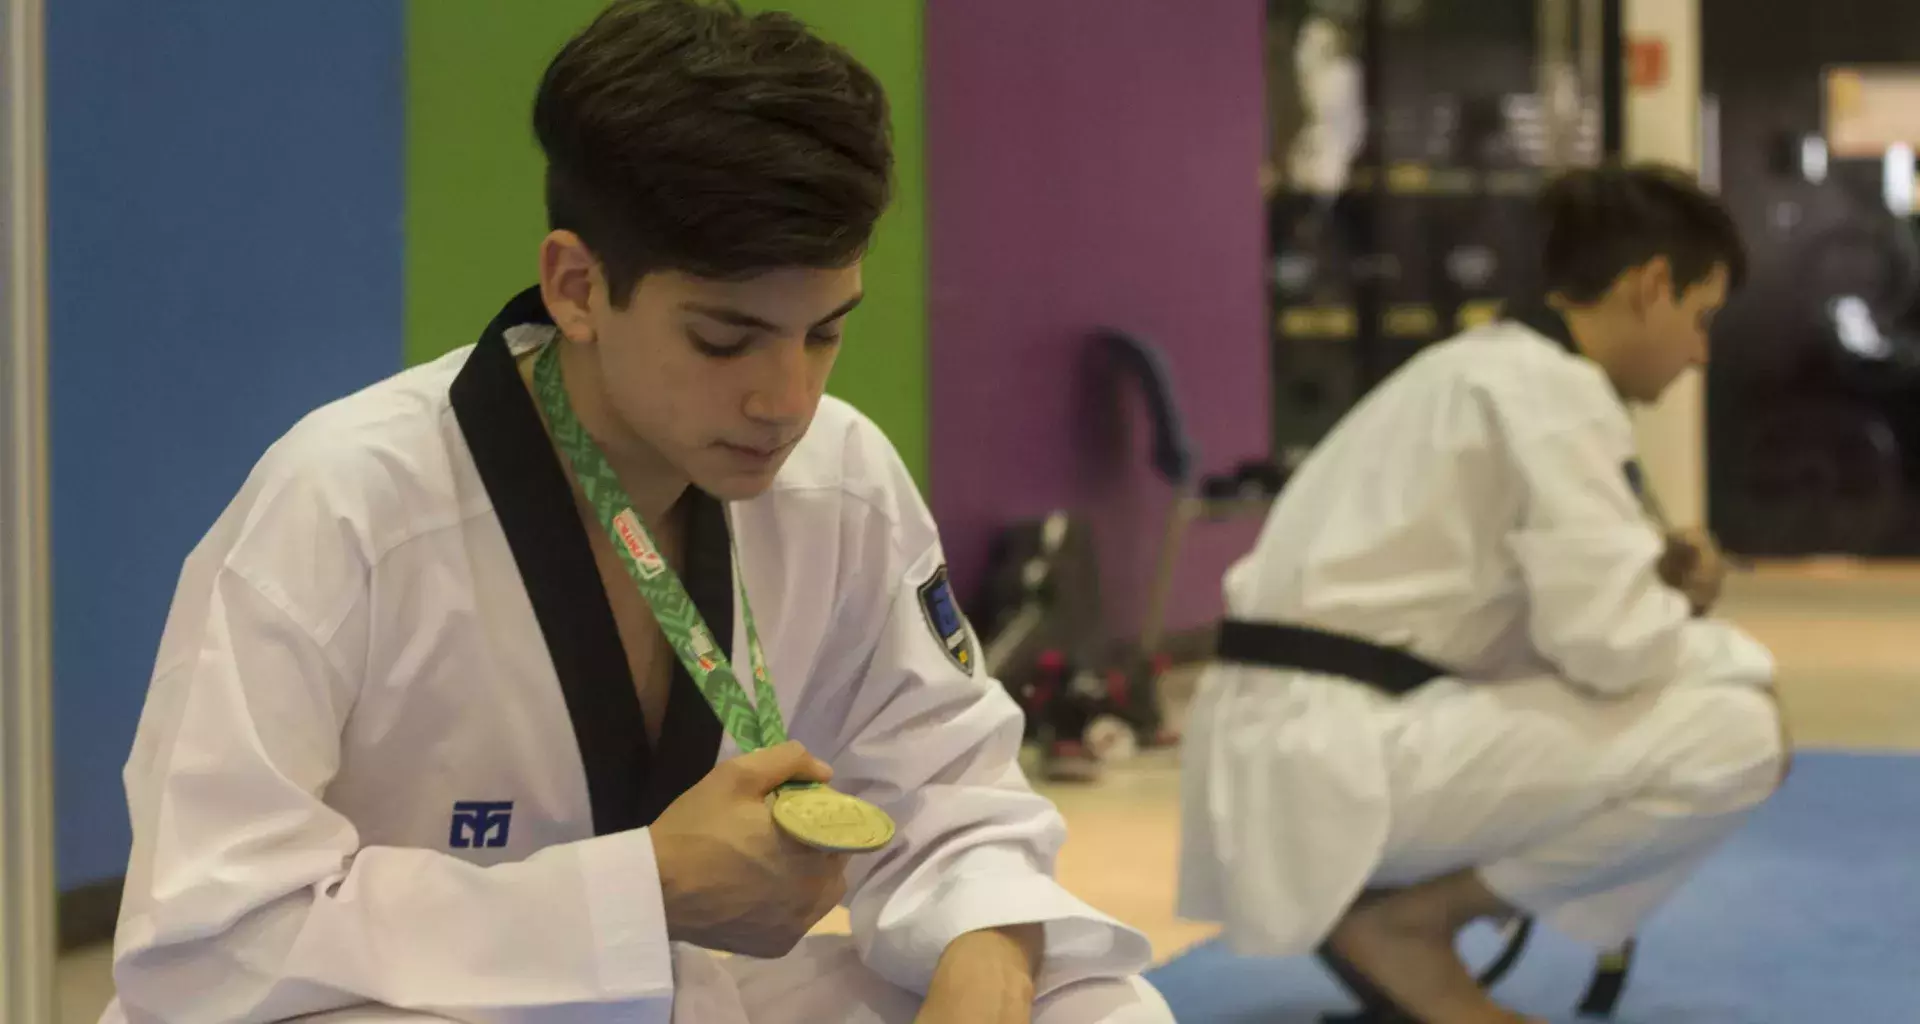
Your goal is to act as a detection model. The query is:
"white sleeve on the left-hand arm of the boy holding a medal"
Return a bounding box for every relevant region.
[113,491,672,1024]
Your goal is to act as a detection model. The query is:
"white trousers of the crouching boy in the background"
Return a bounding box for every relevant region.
[1373,680,1788,947]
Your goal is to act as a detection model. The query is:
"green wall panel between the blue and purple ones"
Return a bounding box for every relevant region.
[405,0,927,488]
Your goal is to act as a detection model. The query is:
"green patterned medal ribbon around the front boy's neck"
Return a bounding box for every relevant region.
[534,338,787,753]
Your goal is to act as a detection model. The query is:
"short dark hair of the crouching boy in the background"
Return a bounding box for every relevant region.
[1540,163,1747,302]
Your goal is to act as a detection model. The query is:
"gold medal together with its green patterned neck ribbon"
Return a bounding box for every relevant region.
[534,344,893,853]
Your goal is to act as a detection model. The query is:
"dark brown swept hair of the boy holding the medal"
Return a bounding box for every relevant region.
[534,0,893,305]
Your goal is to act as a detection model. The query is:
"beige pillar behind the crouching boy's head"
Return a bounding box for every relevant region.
[1624,0,1707,524]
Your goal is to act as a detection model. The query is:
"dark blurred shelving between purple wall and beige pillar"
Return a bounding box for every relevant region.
[1265,0,1622,467]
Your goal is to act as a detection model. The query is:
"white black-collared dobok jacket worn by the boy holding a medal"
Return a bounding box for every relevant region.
[108,290,1148,1024]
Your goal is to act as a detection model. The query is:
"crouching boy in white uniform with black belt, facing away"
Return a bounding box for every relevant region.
[1181,161,1788,1024]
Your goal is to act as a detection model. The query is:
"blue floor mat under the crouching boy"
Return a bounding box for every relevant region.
[1150,753,1920,1024]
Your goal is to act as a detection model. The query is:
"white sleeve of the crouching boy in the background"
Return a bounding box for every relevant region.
[1505,411,1693,695]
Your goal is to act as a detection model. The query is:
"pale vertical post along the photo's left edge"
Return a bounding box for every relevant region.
[0,0,58,1024]
